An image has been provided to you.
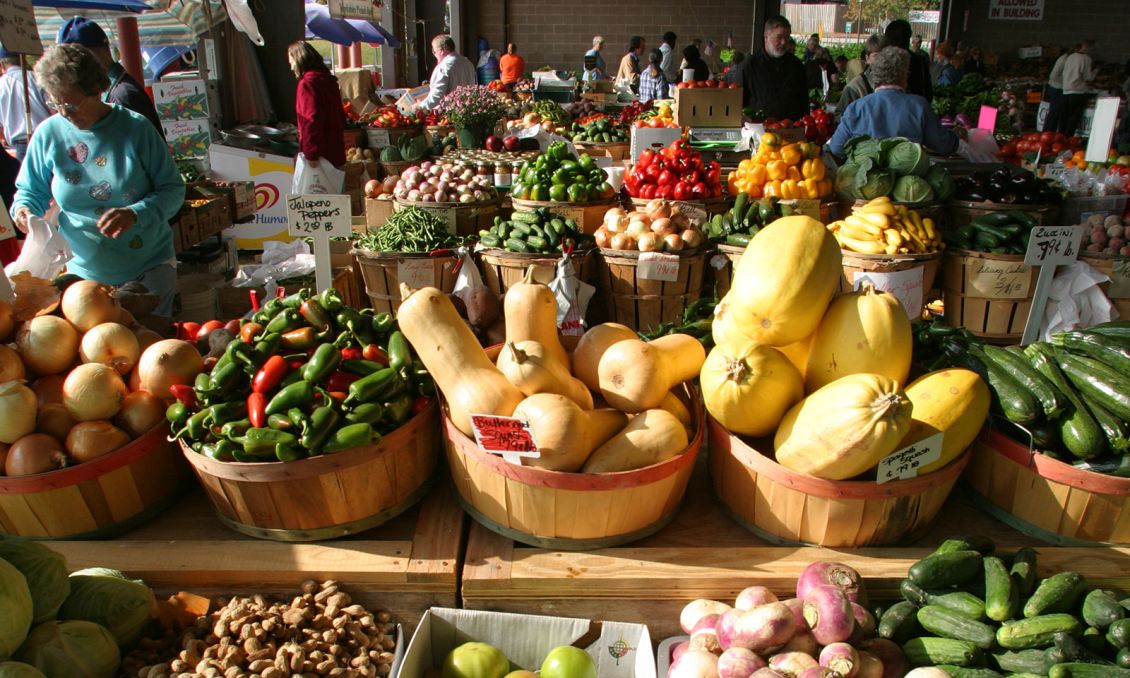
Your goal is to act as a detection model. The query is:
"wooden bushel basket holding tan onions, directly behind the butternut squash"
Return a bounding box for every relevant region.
[597,247,706,330]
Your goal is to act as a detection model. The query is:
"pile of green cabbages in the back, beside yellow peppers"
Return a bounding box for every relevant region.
[835,134,955,205]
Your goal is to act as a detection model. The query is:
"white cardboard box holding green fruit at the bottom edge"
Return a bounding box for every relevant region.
[402,608,655,678]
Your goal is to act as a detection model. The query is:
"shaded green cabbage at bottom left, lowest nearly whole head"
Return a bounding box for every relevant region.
[16,622,121,678]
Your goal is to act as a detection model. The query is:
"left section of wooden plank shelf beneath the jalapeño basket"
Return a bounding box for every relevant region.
[49,483,467,637]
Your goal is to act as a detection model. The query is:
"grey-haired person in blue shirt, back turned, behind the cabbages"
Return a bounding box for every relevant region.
[828,46,958,157]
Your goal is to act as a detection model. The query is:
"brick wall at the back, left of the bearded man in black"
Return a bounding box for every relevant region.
[467,0,759,73]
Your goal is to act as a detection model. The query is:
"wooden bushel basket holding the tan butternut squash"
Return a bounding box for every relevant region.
[443,386,703,550]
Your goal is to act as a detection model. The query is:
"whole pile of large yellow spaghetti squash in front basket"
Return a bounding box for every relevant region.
[699,216,989,480]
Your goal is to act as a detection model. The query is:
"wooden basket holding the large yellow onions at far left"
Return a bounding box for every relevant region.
[0,424,191,539]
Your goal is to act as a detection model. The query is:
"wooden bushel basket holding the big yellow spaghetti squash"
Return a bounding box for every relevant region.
[706,417,970,547]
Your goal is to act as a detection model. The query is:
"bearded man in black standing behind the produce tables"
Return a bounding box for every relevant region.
[741,16,808,120]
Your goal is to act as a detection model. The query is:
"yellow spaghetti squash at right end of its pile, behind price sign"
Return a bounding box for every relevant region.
[895,368,991,476]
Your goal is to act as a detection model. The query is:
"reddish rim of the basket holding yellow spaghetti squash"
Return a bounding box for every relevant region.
[706,415,973,499]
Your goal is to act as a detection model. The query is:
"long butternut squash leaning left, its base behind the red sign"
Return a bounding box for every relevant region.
[397,286,523,436]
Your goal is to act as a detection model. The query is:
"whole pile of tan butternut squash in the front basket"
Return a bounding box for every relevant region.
[398,267,706,473]
